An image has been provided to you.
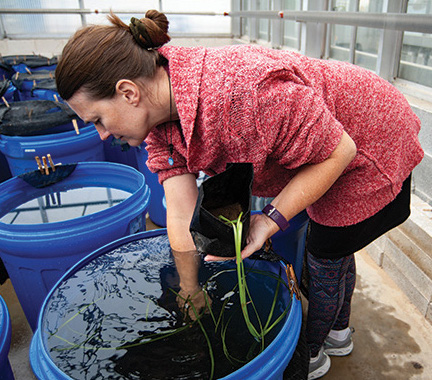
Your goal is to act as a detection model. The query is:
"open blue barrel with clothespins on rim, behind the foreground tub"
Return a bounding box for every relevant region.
[0,162,150,330]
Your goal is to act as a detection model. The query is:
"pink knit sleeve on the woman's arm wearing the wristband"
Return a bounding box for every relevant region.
[257,76,343,169]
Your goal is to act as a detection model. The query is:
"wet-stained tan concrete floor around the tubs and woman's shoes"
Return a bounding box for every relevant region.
[0,238,432,380]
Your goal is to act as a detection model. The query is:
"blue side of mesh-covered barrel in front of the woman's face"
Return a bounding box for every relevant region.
[0,123,105,176]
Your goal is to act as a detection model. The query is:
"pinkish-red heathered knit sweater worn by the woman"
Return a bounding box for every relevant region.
[146,45,423,226]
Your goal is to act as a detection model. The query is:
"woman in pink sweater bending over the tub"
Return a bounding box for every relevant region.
[56,11,423,379]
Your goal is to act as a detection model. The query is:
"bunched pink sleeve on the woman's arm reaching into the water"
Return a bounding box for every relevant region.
[145,122,189,184]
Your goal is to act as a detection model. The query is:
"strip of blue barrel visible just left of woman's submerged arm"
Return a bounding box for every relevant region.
[135,143,166,227]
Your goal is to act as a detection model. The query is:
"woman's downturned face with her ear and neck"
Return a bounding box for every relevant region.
[67,70,169,146]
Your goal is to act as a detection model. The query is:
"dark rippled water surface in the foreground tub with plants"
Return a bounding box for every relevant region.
[41,235,290,379]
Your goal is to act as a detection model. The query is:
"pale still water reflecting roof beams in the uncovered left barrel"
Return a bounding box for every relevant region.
[0,187,131,224]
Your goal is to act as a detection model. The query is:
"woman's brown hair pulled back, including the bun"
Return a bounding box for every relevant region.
[55,10,170,100]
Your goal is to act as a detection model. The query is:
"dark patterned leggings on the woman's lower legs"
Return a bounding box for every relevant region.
[306,252,356,357]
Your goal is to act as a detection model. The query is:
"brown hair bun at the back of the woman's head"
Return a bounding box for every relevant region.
[129,10,171,49]
